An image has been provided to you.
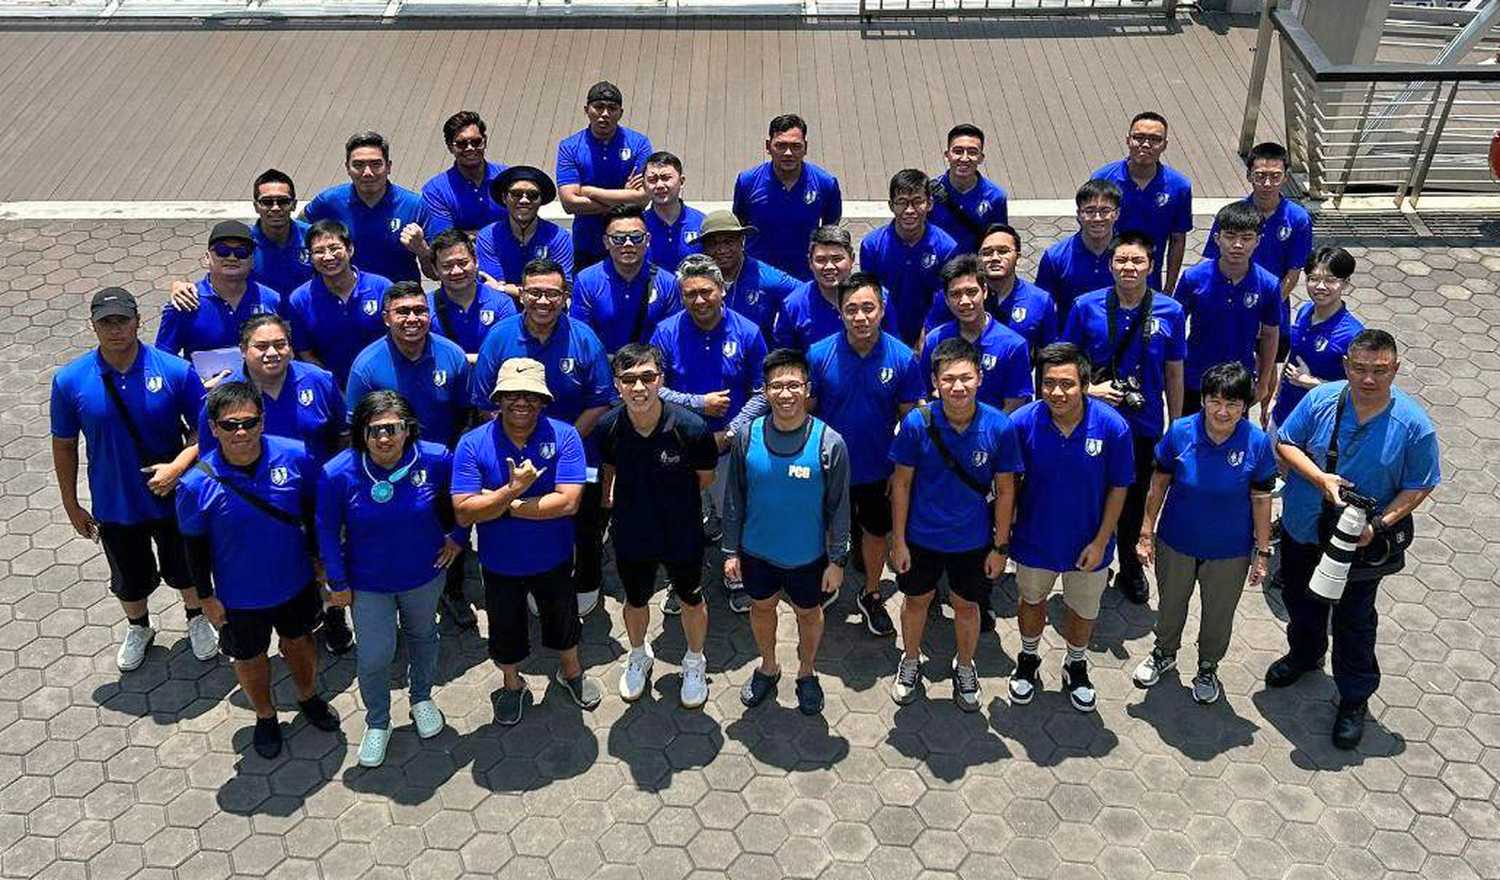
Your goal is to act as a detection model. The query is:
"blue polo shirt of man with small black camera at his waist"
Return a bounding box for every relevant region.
[1062,289,1188,439]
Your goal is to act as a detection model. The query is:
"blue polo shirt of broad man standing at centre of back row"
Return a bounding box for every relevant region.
[734,162,843,282]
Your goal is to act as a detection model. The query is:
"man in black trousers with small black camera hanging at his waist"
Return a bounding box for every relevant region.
[1062,232,1188,604]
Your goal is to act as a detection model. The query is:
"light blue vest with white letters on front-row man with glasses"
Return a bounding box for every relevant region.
[740,415,827,568]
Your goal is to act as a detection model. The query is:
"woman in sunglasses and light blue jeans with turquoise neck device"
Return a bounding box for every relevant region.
[318,391,468,768]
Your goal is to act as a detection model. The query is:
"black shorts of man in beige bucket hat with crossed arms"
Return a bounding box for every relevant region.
[485,559,584,666]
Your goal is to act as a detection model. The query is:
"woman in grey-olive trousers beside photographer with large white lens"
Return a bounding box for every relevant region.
[1134,361,1277,703]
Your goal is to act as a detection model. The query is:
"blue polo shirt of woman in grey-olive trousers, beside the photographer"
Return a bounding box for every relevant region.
[1155,412,1277,559]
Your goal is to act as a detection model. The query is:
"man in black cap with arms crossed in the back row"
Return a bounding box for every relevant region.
[557,81,654,270]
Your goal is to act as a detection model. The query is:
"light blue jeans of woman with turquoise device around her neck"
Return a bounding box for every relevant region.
[353,571,447,729]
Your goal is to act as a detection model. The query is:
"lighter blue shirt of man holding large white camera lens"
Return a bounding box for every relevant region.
[1277,381,1443,544]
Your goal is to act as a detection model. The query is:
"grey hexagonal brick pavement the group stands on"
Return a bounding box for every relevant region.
[0,215,1500,880]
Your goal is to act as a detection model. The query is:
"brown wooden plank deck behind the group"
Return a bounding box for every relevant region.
[0,15,1281,199]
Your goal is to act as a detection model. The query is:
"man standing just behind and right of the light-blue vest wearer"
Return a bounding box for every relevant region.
[807,273,927,636]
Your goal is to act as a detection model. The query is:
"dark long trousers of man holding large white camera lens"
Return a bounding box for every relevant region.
[1281,535,1380,703]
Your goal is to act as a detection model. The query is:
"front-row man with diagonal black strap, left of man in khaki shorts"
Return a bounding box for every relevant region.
[891,337,1022,712]
